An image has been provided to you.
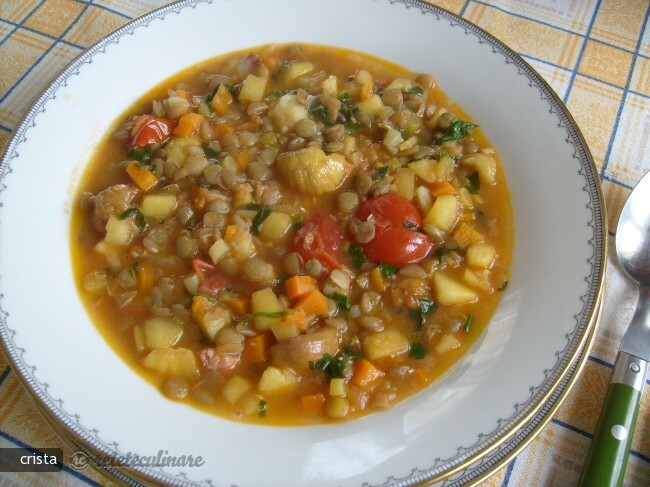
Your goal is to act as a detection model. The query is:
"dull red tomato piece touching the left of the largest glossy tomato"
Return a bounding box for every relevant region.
[291,213,343,272]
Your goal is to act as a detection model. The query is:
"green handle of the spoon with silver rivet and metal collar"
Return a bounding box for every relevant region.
[579,352,648,487]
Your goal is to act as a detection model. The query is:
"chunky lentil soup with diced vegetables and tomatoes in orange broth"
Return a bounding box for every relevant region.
[71,44,513,425]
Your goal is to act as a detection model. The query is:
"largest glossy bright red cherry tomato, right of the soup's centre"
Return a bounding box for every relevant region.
[357,194,432,267]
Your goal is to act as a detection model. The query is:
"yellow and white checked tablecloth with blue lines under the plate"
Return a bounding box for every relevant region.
[0,0,650,487]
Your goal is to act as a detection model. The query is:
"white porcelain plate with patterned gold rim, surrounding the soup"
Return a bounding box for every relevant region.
[0,0,606,487]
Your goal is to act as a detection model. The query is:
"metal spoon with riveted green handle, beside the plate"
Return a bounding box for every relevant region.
[579,173,650,487]
